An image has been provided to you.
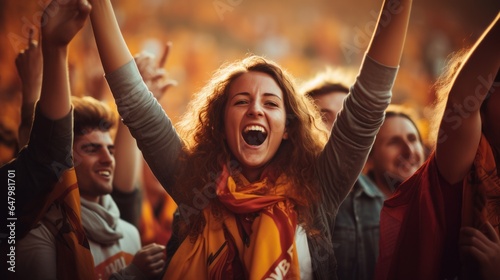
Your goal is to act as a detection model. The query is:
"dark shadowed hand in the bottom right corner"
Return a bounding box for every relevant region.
[459,222,500,280]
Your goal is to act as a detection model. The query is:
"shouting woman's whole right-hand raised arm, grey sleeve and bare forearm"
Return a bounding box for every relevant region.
[317,0,412,212]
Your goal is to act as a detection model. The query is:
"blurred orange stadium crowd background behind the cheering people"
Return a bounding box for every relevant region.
[0,0,500,154]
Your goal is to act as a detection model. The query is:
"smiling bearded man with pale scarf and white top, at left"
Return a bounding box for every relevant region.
[73,97,141,279]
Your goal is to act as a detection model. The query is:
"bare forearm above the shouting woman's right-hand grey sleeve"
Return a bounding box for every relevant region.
[368,0,412,67]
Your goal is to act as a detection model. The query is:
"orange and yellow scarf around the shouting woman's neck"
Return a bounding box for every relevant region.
[163,167,300,280]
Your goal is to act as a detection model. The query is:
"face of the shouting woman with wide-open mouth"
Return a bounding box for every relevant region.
[224,72,288,181]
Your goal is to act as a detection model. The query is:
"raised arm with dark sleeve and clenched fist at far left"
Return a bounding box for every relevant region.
[16,0,90,202]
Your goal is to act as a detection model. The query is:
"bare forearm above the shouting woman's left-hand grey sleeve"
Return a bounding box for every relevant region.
[90,0,133,74]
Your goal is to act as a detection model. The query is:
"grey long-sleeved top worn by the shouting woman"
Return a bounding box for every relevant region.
[106,56,397,279]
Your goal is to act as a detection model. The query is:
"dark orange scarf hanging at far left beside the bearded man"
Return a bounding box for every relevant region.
[21,168,94,280]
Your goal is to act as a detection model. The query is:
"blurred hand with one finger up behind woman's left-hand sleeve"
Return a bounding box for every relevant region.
[134,42,177,100]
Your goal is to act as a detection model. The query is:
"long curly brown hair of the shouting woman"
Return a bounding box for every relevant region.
[174,55,328,236]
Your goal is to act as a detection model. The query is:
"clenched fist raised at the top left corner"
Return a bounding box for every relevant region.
[42,0,91,47]
